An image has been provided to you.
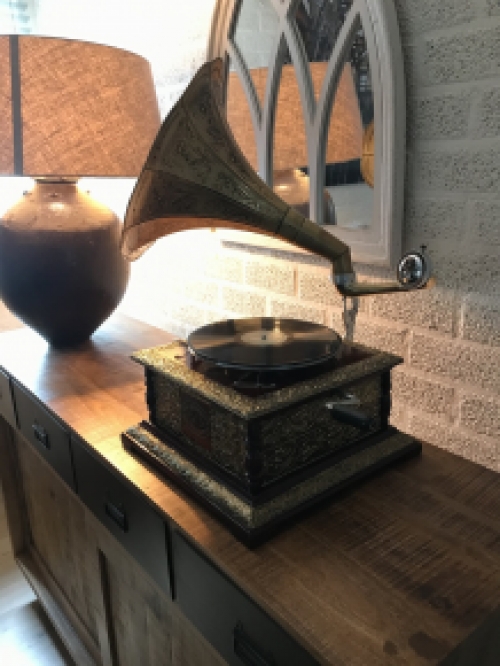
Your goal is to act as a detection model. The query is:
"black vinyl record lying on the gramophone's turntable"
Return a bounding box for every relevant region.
[187,317,342,371]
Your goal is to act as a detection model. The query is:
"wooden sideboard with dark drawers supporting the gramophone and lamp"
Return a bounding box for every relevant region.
[0,315,500,666]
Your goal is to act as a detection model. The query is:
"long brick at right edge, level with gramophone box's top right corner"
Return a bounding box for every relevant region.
[410,334,500,393]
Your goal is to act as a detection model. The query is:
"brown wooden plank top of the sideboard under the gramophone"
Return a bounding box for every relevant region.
[0,315,500,666]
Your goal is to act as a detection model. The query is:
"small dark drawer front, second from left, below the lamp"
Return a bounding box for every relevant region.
[13,382,76,490]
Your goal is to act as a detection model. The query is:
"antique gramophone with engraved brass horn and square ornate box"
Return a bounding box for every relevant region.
[122,59,430,546]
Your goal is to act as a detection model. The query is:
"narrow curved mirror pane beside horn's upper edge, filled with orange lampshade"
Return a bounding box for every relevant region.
[226,58,259,171]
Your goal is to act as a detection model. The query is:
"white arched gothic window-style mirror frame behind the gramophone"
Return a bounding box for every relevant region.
[207,0,406,268]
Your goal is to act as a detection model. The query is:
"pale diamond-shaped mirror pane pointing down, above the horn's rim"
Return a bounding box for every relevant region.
[233,0,279,104]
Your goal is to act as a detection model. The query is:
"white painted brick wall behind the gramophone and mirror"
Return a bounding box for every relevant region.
[121,0,500,471]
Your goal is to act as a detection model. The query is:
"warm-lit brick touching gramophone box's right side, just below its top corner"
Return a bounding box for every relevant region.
[392,366,455,419]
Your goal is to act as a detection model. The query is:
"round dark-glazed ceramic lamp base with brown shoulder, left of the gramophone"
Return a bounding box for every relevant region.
[0,179,129,347]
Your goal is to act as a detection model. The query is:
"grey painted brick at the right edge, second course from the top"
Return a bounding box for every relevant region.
[420,25,500,84]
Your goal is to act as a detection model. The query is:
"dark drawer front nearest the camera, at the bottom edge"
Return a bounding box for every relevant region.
[172,532,318,666]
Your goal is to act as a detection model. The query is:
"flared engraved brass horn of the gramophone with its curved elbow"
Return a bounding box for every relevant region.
[121,58,429,296]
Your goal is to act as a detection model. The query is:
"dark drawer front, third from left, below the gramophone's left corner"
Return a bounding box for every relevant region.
[72,438,170,596]
